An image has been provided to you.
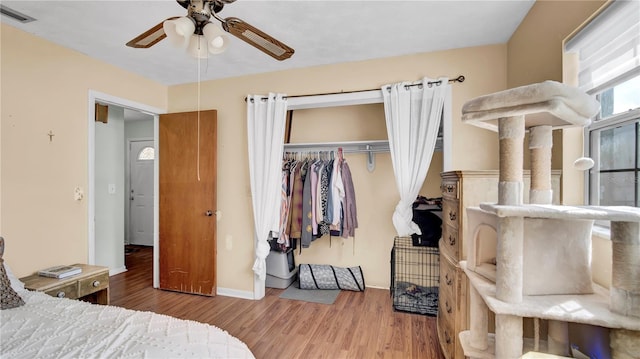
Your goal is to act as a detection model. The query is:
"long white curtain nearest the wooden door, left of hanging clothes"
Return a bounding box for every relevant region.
[247,93,287,281]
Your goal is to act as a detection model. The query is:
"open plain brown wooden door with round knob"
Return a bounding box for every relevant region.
[158,110,217,296]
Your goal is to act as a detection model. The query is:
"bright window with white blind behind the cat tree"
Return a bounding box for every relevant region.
[565,0,640,214]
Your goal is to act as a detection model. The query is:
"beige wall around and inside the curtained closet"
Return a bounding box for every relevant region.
[169,45,506,291]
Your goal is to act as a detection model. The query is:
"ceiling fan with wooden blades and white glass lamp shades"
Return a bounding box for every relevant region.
[127,0,294,61]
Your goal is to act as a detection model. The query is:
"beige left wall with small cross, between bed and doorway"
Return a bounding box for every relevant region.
[0,24,167,276]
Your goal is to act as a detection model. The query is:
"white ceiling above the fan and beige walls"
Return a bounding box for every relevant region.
[0,0,534,85]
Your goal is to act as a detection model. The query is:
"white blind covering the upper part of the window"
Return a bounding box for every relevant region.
[565,0,640,94]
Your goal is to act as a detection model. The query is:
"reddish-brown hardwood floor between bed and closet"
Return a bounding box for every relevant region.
[110,246,444,359]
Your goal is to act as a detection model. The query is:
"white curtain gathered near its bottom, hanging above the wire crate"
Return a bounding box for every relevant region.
[382,78,451,236]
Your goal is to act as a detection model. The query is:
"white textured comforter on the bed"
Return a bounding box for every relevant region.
[0,291,254,358]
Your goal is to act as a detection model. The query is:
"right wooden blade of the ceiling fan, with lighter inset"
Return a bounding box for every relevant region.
[222,17,294,61]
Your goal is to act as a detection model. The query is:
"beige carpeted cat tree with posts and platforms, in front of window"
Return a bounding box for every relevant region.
[460,81,640,359]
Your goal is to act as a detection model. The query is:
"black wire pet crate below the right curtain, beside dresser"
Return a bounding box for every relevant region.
[390,237,440,316]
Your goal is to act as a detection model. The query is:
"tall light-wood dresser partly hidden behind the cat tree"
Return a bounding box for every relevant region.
[438,170,561,359]
